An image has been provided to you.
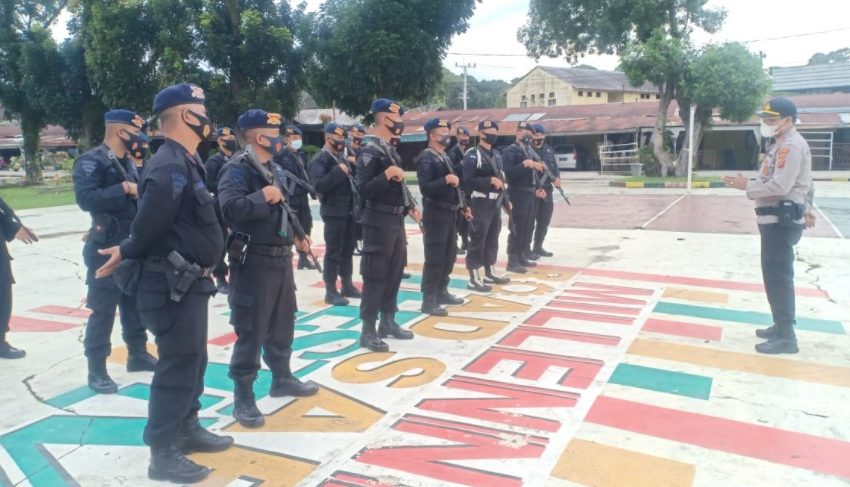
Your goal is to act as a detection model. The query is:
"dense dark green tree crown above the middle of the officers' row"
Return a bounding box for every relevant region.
[308,0,475,114]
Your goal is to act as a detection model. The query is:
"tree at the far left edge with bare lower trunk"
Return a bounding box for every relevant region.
[0,0,65,184]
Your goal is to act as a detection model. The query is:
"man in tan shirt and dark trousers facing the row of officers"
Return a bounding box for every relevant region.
[724,98,815,354]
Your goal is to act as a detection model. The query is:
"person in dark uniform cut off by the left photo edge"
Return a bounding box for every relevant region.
[0,198,38,359]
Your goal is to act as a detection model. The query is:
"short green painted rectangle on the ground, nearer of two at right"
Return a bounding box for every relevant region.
[609,363,712,400]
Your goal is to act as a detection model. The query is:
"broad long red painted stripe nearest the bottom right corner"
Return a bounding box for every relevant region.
[587,396,850,478]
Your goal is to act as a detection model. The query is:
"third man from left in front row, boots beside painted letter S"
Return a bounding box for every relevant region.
[356,98,421,352]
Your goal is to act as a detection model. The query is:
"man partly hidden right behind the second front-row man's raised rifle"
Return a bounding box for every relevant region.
[274,125,316,269]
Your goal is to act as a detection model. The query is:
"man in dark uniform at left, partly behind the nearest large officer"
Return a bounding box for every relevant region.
[72,110,156,394]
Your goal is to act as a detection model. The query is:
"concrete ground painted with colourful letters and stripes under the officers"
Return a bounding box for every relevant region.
[0,185,850,487]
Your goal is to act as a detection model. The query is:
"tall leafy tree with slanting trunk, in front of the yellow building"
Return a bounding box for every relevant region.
[518,0,726,173]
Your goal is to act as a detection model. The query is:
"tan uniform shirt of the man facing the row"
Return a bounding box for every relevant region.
[747,127,814,224]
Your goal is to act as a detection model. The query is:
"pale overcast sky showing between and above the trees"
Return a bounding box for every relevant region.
[54,0,850,81]
